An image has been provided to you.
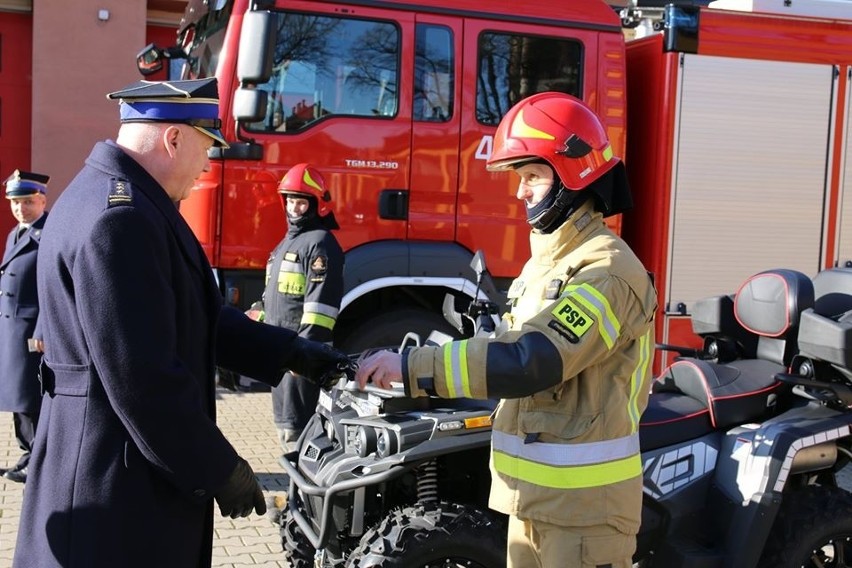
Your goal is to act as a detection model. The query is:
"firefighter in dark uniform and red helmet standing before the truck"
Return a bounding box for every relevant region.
[249,163,344,452]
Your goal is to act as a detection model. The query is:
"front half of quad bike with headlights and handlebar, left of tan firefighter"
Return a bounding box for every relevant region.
[279,253,506,568]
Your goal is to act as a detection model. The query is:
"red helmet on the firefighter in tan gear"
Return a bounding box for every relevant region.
[486,92,620,190]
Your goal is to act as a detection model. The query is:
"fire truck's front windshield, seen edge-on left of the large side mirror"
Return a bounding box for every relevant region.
[178,2,233,79]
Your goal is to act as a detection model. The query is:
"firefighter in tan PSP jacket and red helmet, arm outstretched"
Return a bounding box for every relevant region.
[356,92,656,568]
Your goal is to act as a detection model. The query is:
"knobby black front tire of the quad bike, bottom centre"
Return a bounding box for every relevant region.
[346,503,506,568]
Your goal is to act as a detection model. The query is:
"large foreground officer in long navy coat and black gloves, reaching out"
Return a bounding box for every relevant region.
[13,79,349,568]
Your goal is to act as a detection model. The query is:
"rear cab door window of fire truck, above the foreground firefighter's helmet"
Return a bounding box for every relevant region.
[476,33,581,126]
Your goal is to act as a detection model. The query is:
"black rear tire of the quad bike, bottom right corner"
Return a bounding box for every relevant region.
[758,485,852,568]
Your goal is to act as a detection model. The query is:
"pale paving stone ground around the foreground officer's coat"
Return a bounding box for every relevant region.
[0,389,288,568]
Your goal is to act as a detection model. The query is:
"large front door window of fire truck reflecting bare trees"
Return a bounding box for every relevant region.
[247,12,400,132]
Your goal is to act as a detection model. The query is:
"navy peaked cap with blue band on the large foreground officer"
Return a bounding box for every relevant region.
[107,77,228,148]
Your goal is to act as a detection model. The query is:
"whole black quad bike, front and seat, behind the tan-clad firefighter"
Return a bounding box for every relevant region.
[280,258,852,568]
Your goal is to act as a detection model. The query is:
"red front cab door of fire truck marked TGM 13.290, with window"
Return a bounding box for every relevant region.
[221,1,414,267]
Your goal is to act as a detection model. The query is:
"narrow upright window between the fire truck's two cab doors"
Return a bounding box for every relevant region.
[412,24,455,122]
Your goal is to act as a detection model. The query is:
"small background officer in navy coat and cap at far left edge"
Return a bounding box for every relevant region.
[0,170,50,482]
